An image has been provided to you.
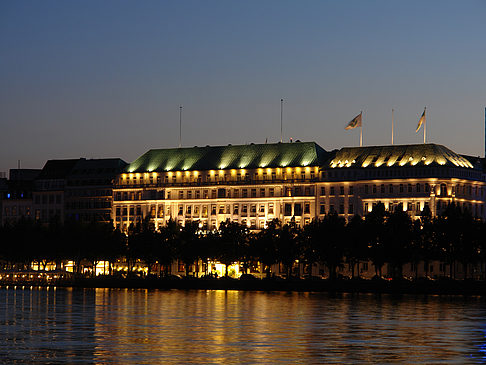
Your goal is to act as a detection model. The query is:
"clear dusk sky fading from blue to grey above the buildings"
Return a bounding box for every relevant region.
[0,0,486,171]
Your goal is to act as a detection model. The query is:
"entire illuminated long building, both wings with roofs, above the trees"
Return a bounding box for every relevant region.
[112,142,486,231]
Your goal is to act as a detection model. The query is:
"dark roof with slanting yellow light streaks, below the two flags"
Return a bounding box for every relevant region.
[329,143,473,168]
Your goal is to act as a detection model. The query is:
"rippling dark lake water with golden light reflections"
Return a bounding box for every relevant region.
[0,288,486,364]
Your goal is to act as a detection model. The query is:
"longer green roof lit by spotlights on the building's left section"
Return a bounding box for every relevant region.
[126,142,330,172]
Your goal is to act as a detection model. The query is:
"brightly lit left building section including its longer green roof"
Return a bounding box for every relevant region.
[113,142,330,230]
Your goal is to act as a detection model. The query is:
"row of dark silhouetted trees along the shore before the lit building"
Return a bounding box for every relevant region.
[0,204,486,288]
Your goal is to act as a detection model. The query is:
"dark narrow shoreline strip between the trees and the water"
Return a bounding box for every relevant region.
[0,277,486,296]
